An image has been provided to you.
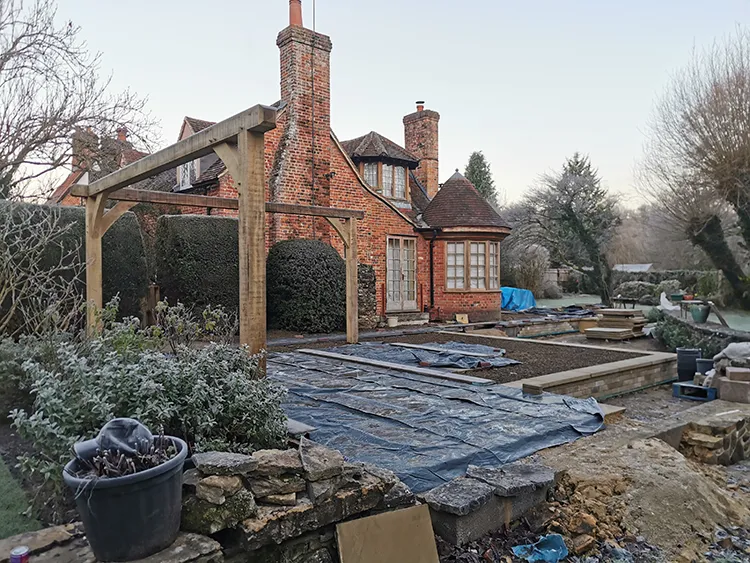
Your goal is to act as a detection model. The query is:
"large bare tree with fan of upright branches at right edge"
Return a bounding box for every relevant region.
[640,29,750,307]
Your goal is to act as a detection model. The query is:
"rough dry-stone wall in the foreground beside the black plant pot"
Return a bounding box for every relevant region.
[0,438,416,563]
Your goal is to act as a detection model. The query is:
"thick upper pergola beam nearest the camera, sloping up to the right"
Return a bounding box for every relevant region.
[75,105,276,197]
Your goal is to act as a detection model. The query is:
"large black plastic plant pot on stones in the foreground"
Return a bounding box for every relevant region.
[63,436,188,561]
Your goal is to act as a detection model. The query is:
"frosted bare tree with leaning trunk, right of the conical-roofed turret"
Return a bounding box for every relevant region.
[514,153,620,305]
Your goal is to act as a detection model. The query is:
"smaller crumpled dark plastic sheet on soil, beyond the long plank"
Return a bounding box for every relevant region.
[328,342,521,369]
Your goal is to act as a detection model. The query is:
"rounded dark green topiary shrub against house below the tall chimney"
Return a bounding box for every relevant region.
[266,240,346,333]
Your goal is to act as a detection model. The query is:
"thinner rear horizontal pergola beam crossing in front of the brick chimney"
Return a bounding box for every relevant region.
[70,184,365,219]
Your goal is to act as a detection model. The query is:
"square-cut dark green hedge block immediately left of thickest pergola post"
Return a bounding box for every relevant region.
[155,215,241,312]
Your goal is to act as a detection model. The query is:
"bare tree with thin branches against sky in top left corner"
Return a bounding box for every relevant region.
[0,0,155,199]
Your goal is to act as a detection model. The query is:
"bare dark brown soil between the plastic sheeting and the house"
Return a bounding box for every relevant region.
[269,332,642,383]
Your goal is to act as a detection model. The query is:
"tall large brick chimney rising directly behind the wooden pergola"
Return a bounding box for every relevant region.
[270,0,333,238]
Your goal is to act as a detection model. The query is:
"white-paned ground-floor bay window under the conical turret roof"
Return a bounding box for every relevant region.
[445,241,500,291]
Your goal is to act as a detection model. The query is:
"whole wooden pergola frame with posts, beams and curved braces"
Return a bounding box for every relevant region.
[71,105,364,362]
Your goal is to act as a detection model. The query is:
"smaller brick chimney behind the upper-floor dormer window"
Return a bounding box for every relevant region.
[404,101,440,198]
